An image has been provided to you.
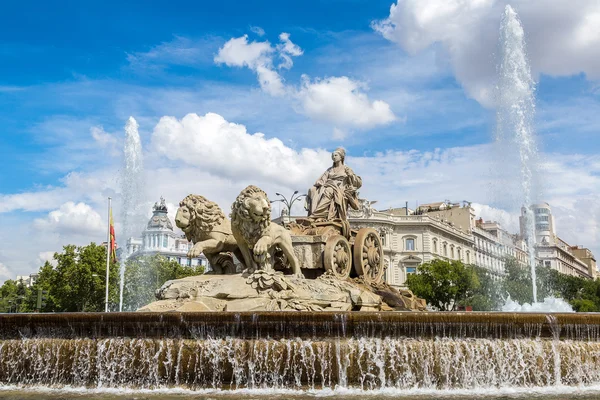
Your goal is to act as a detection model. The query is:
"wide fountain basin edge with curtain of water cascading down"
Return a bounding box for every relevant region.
[0,311,600,393]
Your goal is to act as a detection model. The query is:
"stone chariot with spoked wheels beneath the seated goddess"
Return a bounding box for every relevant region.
[286,218,385,283]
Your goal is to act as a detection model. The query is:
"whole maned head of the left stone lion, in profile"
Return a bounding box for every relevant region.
[175,194,225,243]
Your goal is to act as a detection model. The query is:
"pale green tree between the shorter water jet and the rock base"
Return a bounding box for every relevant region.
[123,255,204,311]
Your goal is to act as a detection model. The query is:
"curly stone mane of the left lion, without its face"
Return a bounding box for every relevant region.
[179,194,225,243]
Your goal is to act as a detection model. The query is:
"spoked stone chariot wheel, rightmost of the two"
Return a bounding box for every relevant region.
[353,228,385,283]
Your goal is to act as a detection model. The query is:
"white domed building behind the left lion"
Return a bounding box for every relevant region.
[124,197,208,267]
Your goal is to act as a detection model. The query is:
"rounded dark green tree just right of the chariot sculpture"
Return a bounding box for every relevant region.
[406,260,480,311]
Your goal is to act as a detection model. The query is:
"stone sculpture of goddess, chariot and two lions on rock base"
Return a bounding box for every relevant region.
[139,145,425,312]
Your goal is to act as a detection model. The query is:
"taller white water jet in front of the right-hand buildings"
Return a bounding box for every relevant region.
[496,5,538,302]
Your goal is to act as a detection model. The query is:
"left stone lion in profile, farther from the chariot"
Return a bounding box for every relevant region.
[175,194,243,274]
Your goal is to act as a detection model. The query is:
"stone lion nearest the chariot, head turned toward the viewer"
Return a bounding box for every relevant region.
[231,185,303,277]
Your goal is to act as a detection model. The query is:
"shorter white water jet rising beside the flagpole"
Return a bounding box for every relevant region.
[119,117,146,311]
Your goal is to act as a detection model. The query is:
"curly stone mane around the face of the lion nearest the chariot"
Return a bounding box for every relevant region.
[230,185,271,248]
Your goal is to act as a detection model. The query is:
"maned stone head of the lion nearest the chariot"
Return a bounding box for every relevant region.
[231,185,271,245]
